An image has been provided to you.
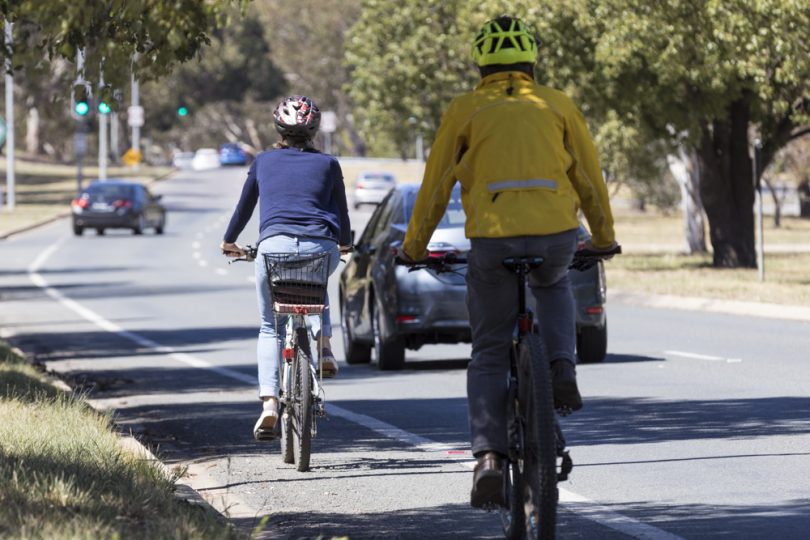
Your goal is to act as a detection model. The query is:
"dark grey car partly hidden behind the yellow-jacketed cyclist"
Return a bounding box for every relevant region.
[340,185,607,369]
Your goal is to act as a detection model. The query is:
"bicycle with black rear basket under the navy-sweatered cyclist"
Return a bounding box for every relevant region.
[229,246,329,472]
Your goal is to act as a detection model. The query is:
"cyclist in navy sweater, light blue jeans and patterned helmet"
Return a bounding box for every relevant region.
[220,96,351,436]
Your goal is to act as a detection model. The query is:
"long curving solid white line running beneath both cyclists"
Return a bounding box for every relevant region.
[28,240,681,540]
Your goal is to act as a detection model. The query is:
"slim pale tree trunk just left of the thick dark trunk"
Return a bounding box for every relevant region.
[667,148,707,254]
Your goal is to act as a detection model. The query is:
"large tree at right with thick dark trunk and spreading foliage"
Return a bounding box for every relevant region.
[538,0,810,267]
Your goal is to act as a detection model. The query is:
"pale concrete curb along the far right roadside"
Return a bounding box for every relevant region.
[608,289,810,322]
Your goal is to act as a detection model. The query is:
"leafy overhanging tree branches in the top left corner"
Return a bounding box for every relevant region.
[0,0,247,87]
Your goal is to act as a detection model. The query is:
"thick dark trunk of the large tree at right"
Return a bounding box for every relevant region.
[697,96,757,268]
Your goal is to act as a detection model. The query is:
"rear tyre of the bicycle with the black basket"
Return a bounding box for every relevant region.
[292,328,312,472]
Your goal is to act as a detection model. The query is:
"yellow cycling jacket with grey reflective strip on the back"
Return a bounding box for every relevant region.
[403,71,614,258]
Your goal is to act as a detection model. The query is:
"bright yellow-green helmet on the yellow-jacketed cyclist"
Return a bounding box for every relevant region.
[472,16,537,66]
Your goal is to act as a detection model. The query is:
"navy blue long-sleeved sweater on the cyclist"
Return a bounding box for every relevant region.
[224,148,351,246]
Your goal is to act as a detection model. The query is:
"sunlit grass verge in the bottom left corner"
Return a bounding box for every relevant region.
[0,341,240,539]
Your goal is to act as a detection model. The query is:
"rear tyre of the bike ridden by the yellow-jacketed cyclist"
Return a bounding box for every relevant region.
[517,334,558,540]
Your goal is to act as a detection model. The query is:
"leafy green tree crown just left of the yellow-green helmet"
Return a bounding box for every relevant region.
[345,0,475,157]
